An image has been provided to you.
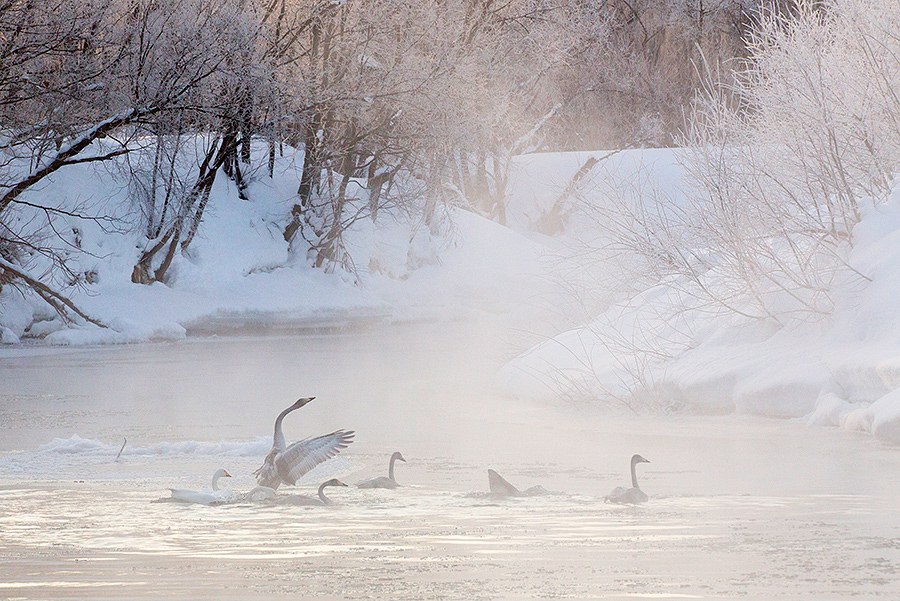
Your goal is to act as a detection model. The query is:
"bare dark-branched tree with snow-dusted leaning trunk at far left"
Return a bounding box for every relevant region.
[0,0,262,314]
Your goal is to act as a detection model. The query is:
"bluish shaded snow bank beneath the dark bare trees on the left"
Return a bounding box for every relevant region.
[0,137,541,345]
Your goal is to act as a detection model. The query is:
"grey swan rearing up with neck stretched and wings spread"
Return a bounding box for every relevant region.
[253,397,355,490]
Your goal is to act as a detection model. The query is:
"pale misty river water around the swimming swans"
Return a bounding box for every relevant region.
[0,321,900,600]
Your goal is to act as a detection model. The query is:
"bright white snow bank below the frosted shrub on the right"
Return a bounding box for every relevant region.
[499,151,900,444]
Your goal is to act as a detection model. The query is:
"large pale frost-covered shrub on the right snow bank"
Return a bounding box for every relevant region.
[676,0,900,322]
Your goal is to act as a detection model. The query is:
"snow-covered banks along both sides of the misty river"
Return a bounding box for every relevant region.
[0,150,900,443]
